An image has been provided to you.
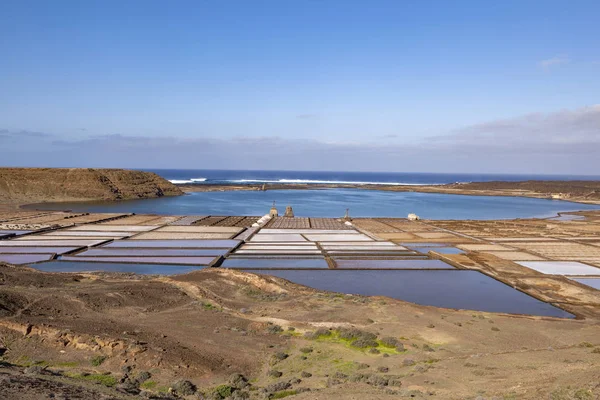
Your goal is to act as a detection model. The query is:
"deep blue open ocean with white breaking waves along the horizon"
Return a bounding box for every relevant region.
[150,169,600,184]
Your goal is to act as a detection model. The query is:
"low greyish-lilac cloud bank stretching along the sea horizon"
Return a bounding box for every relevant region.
[0,105,600,174]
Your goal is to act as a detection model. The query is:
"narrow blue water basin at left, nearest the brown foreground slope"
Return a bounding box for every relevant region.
[30,261,205,275]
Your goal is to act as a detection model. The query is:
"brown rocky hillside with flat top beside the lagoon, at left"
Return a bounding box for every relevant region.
[0,168,183,204]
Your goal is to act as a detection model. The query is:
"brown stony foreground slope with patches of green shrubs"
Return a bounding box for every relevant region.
[0,266,600,399]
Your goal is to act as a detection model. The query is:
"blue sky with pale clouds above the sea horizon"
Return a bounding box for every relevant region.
[0,0,600,174]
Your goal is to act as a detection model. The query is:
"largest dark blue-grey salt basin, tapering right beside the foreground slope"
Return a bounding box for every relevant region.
[245,269,573,318]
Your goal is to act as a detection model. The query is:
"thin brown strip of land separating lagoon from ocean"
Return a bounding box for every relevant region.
[178,181,600,204]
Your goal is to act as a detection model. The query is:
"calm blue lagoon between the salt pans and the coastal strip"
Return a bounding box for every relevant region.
[36,189,600,219]
